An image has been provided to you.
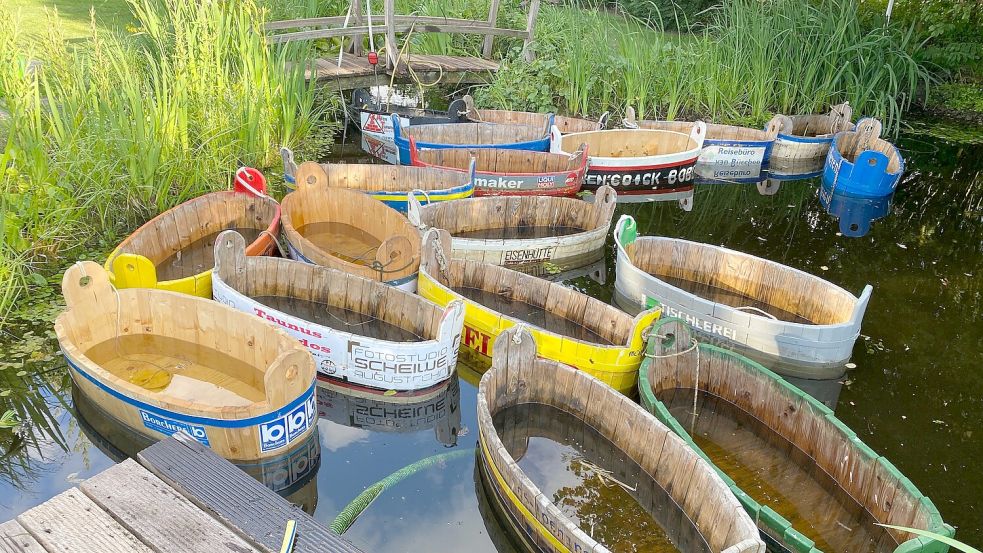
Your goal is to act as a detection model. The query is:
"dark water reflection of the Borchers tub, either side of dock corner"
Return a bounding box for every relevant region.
[78,389,321,514]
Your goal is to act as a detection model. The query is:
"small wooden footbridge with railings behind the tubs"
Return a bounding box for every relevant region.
[265,0,540,90]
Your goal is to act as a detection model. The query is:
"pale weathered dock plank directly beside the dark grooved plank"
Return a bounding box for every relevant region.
[79,459,257,553]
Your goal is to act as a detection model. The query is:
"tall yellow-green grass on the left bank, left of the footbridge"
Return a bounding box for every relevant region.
[0,0,326,326]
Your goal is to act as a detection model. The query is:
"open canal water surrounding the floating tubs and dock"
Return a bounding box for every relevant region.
[0,121,983,553]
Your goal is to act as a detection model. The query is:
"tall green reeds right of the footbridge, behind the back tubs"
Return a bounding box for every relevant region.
[479,0,929,131]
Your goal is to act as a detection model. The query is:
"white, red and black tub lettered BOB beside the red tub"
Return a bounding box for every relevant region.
[551,122,706,207]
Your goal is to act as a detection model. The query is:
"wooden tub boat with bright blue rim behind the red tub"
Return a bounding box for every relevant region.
[392,114,553,165]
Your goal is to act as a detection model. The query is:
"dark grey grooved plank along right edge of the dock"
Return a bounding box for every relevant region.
[139,433,359,553]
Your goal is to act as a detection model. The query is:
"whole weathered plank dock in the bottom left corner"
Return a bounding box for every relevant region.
[0,434,359,553]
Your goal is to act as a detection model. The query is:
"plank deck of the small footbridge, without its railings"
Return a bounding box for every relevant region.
[304,53,498,90]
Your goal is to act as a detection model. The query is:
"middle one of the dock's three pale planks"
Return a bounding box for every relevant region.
[17,488,152,553]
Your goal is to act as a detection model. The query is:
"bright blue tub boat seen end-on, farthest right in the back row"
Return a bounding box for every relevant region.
[823,118,904,198]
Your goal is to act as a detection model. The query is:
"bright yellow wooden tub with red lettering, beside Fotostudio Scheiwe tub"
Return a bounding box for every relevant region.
[419,229,660,394]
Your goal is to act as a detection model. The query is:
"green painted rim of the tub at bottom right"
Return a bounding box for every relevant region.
[638,317,955,553]
